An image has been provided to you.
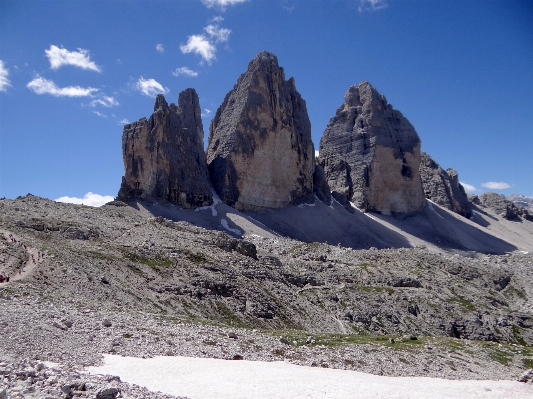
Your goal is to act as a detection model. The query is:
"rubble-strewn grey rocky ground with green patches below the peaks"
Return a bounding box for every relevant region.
[0,195,533,399]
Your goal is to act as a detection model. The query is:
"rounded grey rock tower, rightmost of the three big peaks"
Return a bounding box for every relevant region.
[320,82,426,214]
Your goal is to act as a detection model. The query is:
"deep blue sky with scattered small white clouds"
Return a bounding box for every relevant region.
[0,0,533,205]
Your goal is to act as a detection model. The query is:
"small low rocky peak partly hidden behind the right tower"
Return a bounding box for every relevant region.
[420,152,472,219]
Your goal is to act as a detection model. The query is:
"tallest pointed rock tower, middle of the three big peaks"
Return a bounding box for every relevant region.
[207,51,315,210]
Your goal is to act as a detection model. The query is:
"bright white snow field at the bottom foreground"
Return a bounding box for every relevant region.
[85,355,533,399]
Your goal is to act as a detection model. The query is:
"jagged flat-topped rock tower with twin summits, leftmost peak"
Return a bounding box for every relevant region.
[117,89,213,208]
